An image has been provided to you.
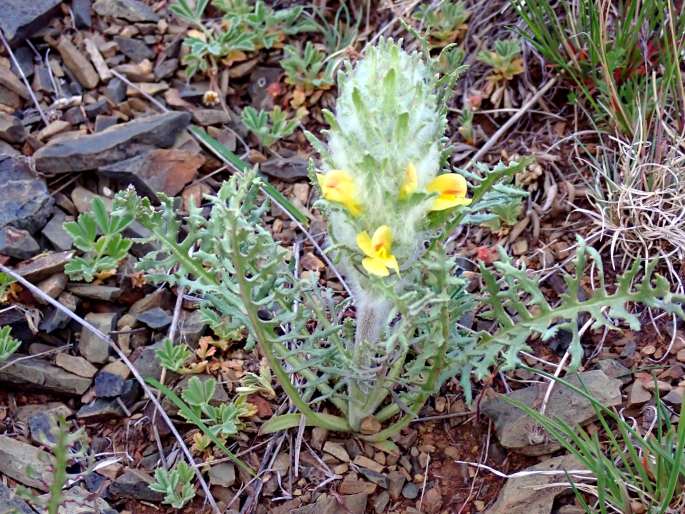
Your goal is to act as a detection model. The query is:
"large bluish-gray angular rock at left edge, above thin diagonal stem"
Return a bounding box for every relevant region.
[0,155,54,234]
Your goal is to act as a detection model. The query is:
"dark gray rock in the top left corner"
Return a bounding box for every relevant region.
[0,0,62,45]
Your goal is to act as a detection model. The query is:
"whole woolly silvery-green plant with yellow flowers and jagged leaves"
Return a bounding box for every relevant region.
[114,40,682,442]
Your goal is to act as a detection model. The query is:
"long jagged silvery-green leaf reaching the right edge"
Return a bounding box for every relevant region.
[464,238,685,388]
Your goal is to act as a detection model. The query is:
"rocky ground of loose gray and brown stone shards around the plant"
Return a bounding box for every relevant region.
[0,0,685,514]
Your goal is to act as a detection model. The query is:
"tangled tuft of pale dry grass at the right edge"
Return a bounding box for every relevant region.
[579,121,685,291]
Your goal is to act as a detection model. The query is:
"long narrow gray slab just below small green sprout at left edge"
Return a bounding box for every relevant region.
[0,354,92,395]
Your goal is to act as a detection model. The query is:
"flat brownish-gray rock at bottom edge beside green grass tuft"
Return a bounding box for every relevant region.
[486,455,584,514]
